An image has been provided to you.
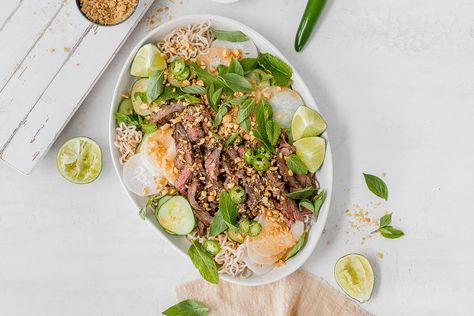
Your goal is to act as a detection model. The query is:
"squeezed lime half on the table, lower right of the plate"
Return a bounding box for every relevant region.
[334,254,374,303]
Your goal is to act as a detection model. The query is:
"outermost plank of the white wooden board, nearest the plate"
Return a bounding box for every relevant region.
[0,1,152,174]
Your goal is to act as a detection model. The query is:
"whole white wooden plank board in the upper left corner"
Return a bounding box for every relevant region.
[0,0,153,175]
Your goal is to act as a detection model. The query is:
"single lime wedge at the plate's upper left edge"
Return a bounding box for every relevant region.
[130,44,166,77]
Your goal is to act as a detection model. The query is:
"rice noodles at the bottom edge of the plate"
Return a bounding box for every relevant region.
[188,232,252,278]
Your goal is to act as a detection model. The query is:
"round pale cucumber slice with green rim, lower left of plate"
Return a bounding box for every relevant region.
[155,196,196,235]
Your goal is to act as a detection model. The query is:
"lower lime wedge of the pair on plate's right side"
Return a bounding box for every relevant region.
[293,135,326,172]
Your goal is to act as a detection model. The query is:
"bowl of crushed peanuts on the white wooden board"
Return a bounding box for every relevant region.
[77,0,138,25]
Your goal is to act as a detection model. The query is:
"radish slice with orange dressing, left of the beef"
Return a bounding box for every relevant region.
[140,127,176,185]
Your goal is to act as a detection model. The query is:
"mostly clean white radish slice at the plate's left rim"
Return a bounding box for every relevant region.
[122,154,167,196]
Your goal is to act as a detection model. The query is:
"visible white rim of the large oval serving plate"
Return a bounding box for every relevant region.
[109,14,332,286]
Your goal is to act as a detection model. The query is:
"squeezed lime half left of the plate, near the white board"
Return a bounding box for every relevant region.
[56,137,102,183]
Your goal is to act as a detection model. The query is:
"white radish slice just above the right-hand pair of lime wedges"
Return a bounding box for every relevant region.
[262,86,304,128]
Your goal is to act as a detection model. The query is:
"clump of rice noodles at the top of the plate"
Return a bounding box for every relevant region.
[158,21,213,61]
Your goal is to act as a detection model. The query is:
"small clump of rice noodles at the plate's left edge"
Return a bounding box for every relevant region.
[114,122,143,165]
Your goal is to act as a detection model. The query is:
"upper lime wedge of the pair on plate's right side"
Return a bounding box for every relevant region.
[291,105,327,140]
